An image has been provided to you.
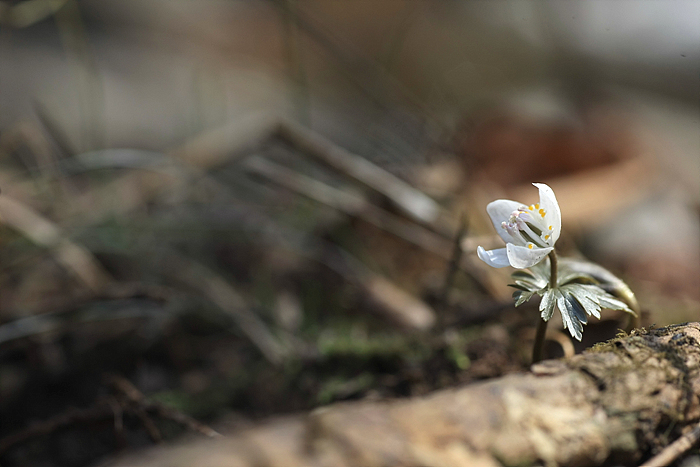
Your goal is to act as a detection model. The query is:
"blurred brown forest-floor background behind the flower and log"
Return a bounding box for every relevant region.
[0,0,700,467]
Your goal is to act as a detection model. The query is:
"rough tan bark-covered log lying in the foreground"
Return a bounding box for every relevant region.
[106,323,700,467]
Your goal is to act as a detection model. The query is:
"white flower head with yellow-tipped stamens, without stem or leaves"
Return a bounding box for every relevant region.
[476,183,561,269]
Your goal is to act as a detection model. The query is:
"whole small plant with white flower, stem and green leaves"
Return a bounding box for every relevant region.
[477,183,638,363]
